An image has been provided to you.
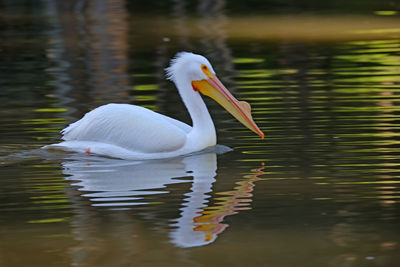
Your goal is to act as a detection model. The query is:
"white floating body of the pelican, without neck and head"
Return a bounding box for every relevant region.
[57,104,216,159]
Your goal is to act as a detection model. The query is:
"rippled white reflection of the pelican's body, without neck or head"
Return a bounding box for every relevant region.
[63,151,219,206]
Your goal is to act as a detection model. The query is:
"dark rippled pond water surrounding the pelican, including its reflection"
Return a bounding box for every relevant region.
[0,1,400,266]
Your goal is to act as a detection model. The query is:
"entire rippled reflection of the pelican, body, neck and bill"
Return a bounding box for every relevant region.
[63,152,258,247]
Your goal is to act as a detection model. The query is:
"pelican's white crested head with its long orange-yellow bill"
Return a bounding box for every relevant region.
[166,52,264,138]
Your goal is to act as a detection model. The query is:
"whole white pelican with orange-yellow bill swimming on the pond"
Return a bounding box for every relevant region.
[47,52,264,160]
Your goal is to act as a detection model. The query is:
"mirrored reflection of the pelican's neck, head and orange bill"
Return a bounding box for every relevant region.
[171,167,264,247]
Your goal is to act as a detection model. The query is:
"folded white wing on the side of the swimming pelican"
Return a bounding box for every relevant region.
[62,104,191,153]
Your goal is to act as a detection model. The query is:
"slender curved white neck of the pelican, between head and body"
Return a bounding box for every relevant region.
[175,76,216,146]
